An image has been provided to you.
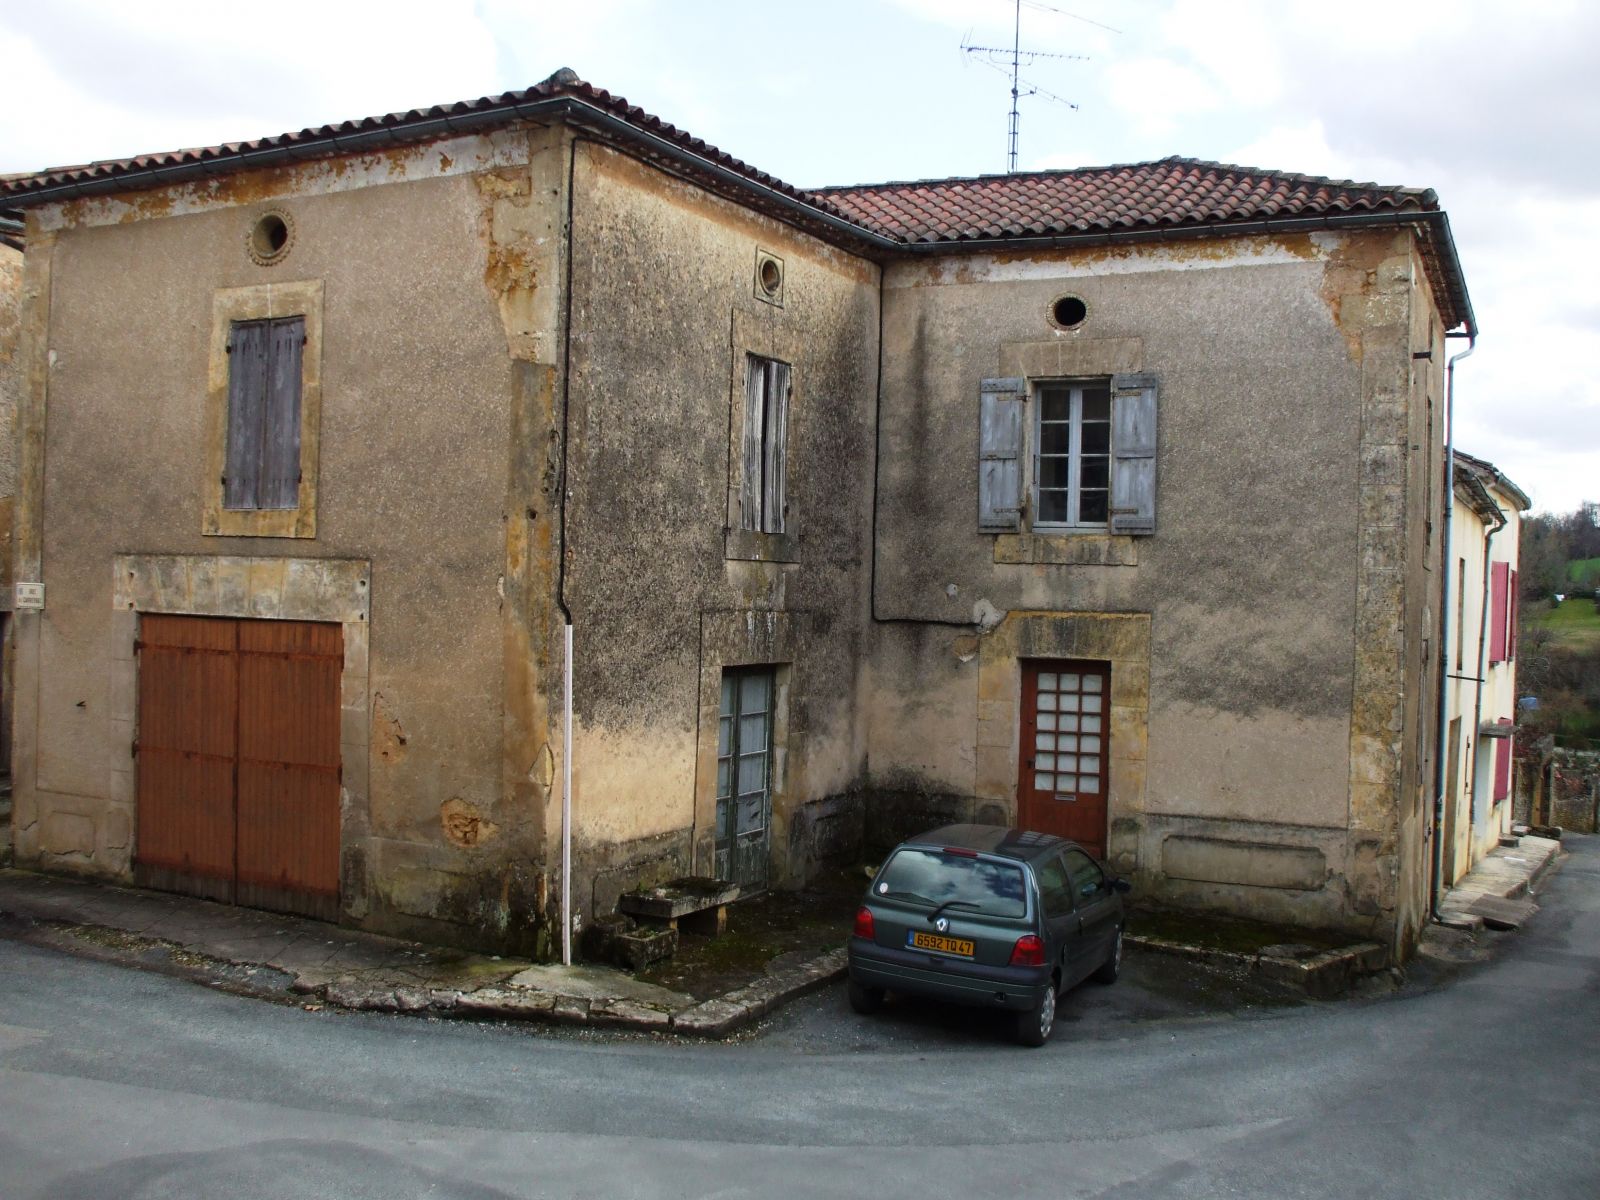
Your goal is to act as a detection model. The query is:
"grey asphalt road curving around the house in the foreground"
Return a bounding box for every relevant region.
[0,838,1600,1200]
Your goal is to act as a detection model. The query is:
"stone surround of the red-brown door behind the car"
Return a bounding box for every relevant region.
[973,611,1150,874]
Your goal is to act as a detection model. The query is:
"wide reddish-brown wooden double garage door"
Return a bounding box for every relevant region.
[134,614,344,920]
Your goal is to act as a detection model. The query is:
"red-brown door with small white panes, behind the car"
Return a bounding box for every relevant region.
[1016,659,1110,858]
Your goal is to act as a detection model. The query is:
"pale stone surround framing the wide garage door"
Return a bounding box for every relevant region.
[109,554,371,910]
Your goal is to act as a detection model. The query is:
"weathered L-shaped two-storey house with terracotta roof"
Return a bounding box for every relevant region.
[0,72,1472,955]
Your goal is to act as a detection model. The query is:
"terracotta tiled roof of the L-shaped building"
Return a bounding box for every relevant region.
[0,69,1470,323]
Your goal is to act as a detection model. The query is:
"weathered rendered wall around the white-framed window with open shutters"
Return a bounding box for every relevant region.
[867,234,1442,954]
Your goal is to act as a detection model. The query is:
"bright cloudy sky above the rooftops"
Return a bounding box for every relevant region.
[0,0,1600,510]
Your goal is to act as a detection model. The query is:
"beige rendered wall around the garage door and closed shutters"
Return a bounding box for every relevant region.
[14,130,565,950]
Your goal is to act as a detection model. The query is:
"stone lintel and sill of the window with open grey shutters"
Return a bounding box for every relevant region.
[994,334,1144,566]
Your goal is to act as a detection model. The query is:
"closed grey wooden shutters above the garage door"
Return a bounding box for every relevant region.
[222,317,306,510]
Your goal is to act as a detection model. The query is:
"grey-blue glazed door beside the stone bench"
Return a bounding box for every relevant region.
[717,667,776,888]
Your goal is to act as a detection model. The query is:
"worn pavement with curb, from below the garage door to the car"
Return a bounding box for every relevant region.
[0,870,845,1037]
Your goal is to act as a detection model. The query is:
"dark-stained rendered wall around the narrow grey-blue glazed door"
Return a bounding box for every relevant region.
[566,141,878,914]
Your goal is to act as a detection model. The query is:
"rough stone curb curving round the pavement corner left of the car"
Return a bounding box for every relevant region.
[318,947,846,1038]
